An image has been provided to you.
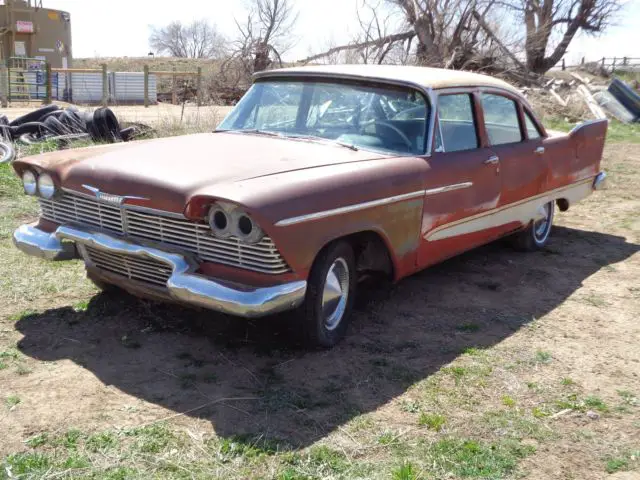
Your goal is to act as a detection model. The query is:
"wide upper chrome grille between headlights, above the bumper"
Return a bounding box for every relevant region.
[39,192,290,274]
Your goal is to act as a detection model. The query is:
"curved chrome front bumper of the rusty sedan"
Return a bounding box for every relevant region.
[13,225,307,318]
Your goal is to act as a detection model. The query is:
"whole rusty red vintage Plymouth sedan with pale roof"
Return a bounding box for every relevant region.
[13,65,607,347]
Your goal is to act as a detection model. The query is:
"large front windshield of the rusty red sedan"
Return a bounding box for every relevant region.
[218,81,429,155]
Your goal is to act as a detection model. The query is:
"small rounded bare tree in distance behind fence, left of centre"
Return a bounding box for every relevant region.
[149,20,224,58]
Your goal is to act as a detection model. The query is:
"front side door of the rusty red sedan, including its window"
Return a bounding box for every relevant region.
[418,90,501,268]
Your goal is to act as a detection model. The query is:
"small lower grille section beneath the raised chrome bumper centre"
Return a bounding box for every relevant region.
[83,245,172,287]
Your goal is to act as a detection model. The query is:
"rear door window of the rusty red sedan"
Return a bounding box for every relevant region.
[482,93,522,145]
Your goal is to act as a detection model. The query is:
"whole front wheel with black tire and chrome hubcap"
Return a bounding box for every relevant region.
[298,241,357,348]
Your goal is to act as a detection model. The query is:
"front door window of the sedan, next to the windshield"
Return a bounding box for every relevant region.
[436,93,478,152]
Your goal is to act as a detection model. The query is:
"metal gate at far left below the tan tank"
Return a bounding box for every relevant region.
[7,57,47,102]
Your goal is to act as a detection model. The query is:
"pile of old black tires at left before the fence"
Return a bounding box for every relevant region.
[0,105,139,163]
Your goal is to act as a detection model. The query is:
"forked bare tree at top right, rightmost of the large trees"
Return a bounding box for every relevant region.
[501,0,621,74]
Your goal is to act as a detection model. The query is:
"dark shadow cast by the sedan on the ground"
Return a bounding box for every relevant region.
[17,227,640,449]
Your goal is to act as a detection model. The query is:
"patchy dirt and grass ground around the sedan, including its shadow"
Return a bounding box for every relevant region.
[0,125,640,480]
